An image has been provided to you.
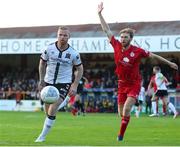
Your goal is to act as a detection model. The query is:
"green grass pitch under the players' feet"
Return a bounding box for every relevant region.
[0,111,180,146]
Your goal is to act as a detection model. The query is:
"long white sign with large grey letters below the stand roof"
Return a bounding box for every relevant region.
[0,35,180,54]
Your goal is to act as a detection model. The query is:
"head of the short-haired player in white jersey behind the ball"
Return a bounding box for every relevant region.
[57,29,70,45]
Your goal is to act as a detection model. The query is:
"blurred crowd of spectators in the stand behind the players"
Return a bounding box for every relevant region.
[0,57,180,112]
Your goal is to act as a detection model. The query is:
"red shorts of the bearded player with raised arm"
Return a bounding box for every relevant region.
[117,81,141,104]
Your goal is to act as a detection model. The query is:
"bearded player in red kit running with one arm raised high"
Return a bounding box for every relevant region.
[98,3,178,141]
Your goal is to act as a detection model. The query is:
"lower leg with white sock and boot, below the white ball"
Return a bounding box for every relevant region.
[35,98,63,142]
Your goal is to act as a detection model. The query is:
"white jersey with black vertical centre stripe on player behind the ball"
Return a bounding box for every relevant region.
[41,42,82,84]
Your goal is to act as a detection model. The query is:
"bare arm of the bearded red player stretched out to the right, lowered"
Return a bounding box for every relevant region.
[150,53,178,70]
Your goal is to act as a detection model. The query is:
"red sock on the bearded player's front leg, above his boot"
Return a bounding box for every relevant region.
[118,116,130,137]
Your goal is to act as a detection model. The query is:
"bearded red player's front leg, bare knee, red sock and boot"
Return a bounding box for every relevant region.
[117,97,136,141]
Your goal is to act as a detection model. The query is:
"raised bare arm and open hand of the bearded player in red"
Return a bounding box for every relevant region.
[98,2,113,41]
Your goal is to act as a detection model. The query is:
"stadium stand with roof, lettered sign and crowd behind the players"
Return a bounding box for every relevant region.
[0,21,180,112]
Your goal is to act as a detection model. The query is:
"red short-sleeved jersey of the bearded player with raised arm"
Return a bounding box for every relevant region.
[110,36,150,83]
